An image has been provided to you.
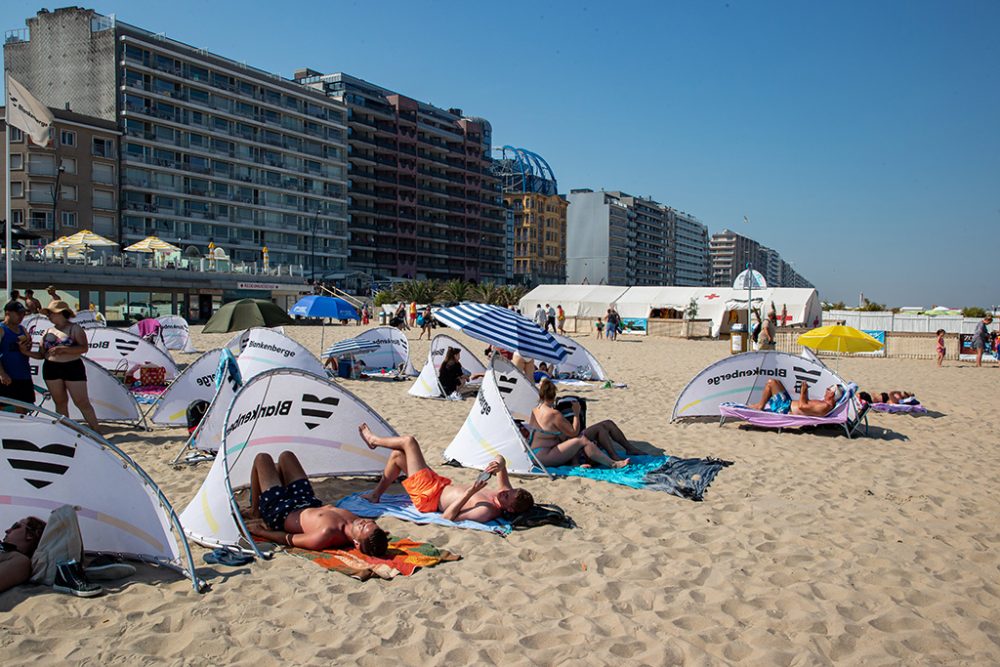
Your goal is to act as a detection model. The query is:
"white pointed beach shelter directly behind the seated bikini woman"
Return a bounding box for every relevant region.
[443,354,545,475]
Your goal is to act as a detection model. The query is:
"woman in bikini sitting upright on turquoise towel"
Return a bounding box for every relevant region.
[528,378,629,468]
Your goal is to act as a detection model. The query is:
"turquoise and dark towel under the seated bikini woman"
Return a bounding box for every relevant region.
[548,456,733,501]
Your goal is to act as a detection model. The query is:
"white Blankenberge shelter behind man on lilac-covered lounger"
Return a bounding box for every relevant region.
[670,350,845,421]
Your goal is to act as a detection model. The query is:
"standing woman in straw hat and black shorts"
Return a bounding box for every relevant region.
[42,301,100,433]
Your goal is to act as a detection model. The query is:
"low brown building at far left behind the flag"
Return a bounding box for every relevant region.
[0,107,121,243]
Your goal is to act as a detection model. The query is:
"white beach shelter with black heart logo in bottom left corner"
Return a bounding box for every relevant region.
[0,399,201,590]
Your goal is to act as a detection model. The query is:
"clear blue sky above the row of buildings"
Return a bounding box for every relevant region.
[0,0,1000,307]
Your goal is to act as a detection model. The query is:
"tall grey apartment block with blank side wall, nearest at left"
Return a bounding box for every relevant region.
[4,7,348,278]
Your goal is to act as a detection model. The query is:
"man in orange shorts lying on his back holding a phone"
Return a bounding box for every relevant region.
[358,424,535,523]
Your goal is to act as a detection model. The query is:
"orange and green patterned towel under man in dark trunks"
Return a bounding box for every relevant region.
[285,535,462,581]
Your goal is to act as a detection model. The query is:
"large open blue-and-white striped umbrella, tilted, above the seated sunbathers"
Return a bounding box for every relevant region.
[434,303,567,363]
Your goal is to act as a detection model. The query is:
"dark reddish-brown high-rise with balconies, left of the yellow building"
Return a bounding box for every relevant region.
[295,69,507,282]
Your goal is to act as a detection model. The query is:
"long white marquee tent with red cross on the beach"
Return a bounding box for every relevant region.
[520,285,822,336]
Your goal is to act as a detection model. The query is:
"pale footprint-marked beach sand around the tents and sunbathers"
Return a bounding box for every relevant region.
[0,327,1000,665]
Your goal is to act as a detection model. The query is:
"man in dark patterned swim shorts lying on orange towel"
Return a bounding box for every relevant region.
[247,452,389,558]
